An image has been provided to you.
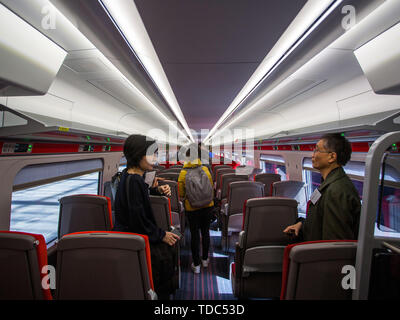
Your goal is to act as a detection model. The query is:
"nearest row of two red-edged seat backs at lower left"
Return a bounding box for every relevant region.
[0,231,157,300]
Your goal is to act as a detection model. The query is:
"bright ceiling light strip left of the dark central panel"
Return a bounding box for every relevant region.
[98,0,194,142]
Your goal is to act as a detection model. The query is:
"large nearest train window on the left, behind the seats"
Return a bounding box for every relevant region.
[10,172,100,243]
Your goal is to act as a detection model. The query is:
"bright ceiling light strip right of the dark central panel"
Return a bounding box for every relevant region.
[204,0,343,143]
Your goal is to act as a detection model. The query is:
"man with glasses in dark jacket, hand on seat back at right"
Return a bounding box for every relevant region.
[283,134,361,241]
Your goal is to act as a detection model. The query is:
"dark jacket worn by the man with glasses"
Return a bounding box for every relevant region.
[301,167,361,241]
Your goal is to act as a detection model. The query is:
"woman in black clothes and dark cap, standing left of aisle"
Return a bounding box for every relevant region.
[114,135,179,298]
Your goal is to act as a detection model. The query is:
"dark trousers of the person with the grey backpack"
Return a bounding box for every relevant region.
[186,207,213,266]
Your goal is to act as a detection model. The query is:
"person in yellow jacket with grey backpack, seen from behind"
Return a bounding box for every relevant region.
[178,145,214,273]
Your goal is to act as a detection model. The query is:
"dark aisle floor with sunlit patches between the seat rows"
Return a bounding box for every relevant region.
[174,228,236,300]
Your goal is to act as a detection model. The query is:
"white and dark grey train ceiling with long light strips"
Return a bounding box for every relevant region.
[0,0,400,144]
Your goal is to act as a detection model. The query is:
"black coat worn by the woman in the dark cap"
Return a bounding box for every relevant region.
[114,170,165,243]
